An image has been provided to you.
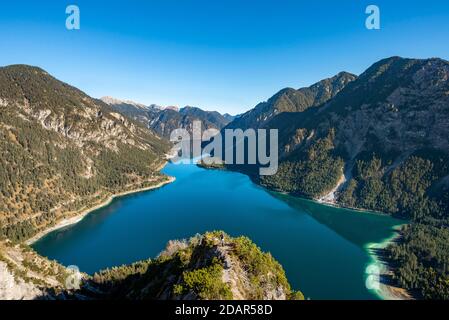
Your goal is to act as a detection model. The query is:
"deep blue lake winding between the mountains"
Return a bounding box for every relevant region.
[33,164,401,299]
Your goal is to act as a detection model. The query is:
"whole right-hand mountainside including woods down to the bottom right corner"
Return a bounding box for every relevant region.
[223,57,449,299]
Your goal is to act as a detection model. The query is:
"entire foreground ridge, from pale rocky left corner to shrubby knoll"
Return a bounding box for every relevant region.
[0,232,304,300]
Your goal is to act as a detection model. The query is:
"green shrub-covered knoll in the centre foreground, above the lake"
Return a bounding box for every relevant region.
[91,231,304,300]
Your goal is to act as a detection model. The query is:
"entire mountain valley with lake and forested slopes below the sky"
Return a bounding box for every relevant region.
[0,57,449,300]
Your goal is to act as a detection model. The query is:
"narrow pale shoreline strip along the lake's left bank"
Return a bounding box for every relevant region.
[24,163,176,246]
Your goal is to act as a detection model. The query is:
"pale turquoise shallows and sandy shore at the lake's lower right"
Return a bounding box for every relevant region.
[365,224,413,300]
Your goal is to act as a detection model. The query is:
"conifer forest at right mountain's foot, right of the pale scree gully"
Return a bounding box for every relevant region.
[340,151,449,220]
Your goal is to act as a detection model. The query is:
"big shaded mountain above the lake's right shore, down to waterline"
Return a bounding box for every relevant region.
[252,56,449,217]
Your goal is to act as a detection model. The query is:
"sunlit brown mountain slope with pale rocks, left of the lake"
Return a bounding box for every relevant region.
[0,65,169,240]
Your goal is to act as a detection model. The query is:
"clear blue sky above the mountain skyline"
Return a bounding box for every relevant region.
[0,0,449,114]
